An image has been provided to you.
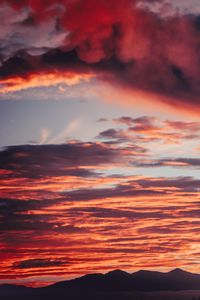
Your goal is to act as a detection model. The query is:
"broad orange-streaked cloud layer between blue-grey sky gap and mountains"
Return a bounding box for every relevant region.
[0,116,200,285]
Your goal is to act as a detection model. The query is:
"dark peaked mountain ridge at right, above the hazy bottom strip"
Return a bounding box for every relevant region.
[48,269,200,291]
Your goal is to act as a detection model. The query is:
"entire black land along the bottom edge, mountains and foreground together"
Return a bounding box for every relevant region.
[0,269,200,300]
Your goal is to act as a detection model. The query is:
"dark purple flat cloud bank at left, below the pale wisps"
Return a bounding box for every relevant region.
[0,141,135,178]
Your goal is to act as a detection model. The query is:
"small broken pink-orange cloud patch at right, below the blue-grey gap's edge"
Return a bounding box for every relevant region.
[98,116,200,145]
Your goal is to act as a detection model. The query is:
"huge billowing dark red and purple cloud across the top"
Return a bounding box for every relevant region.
[0,0,200,105]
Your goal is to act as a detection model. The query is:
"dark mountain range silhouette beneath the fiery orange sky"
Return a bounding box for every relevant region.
[0,269,200,300]
